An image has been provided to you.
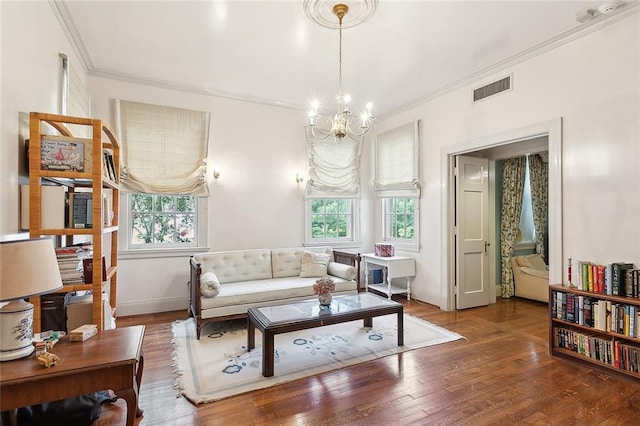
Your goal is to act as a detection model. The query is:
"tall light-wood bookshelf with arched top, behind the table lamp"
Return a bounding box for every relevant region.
[29,112,120,332]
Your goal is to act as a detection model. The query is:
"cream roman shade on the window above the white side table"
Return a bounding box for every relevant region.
[374,121,420,198]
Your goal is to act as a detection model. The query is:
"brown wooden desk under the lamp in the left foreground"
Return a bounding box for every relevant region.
[0,325,144,426]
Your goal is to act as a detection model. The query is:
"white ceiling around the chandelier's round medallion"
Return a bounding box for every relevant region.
[58,0,638,116]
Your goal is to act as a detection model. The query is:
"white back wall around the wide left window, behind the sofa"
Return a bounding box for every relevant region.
[89,77,306,315]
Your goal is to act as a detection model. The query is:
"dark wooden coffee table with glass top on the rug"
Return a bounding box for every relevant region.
[247,293,404,377]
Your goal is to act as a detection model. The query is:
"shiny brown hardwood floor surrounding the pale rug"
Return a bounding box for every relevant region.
[95,296,640,425]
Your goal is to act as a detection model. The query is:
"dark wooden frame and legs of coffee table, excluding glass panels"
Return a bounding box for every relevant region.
[247,293,404,377]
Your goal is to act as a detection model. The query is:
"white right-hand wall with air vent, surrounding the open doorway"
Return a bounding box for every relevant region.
[375,12,640,306]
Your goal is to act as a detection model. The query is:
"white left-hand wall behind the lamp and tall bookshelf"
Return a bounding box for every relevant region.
[0,1,85,239]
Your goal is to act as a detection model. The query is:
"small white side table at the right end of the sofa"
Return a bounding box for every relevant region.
[360,253,416,300]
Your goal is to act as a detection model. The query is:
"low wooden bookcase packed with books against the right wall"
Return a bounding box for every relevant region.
[549,284,640,379]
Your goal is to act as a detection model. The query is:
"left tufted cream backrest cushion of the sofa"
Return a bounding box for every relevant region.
[193,249,272,284]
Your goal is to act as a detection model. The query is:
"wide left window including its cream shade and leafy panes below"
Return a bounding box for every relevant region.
[116,101,210,255]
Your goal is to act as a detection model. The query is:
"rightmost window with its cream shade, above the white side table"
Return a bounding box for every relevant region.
[374,121,420,251]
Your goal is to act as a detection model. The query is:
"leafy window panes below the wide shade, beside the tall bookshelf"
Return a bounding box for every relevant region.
[129,193,198,248]
